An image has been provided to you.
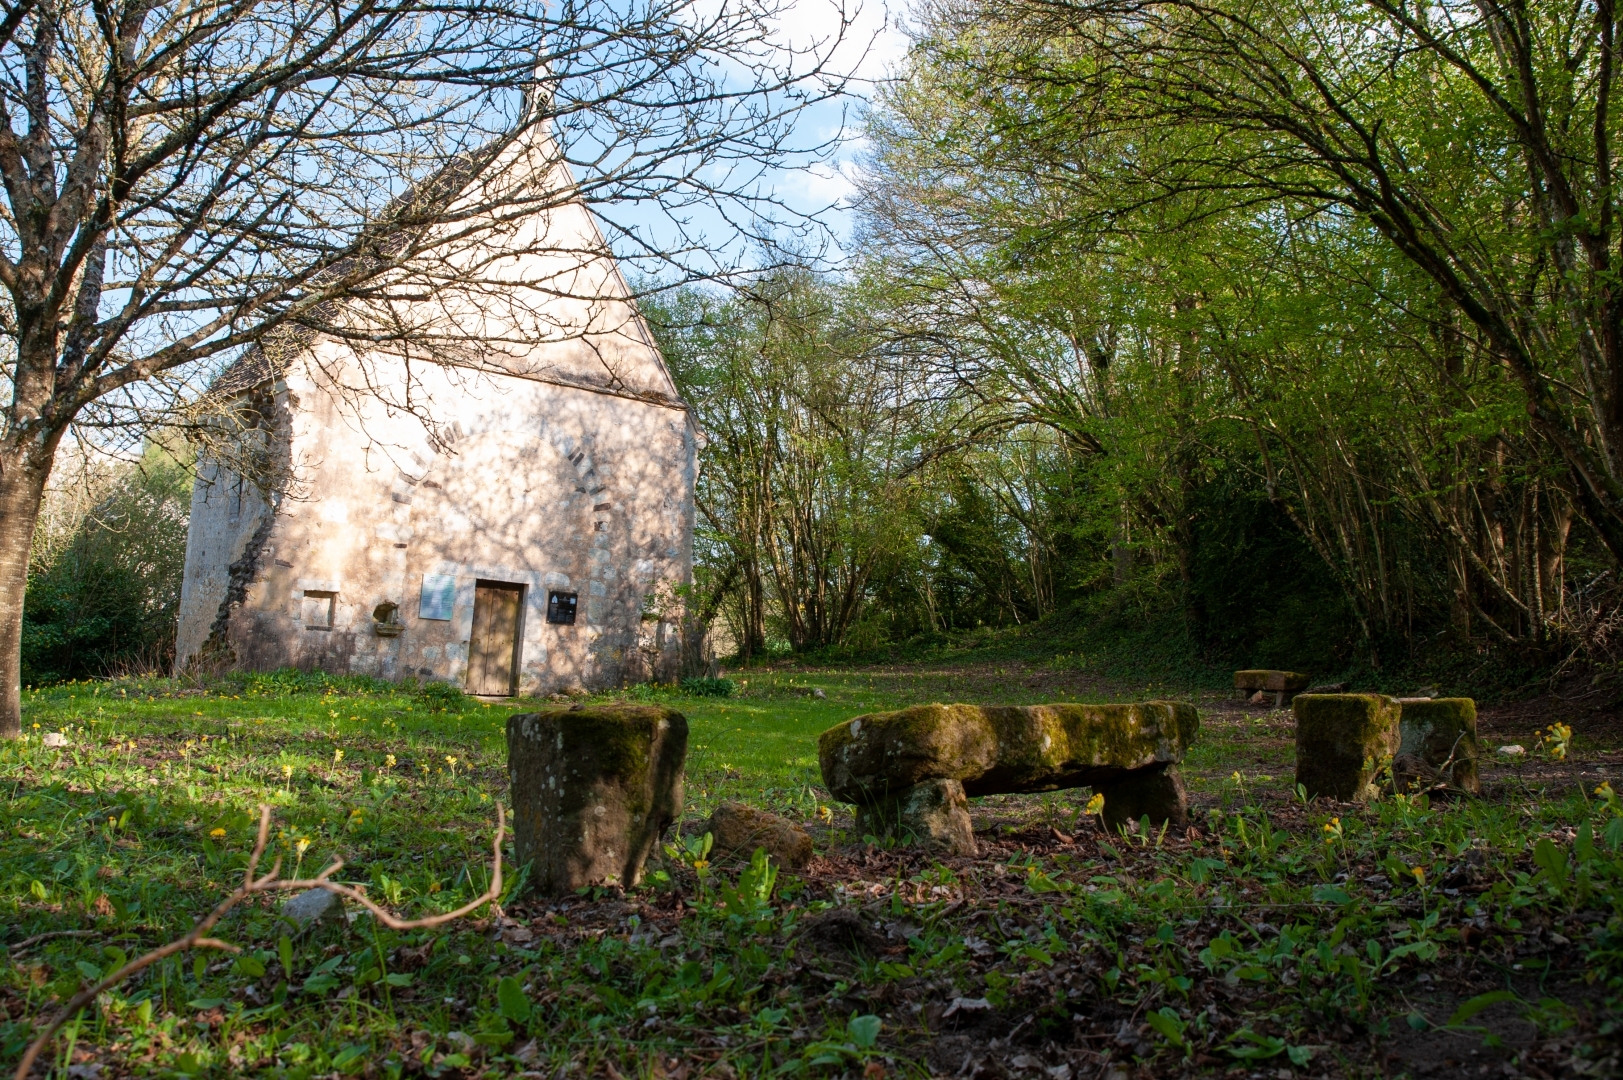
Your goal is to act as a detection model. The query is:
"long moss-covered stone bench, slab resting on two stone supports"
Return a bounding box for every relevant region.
[818,702,1199,854]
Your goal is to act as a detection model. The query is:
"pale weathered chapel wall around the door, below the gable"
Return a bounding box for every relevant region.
[177,346,695,693]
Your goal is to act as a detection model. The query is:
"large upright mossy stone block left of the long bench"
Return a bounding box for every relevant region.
[508,705,688,896]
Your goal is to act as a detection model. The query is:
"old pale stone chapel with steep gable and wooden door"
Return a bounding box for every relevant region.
[177,120,696,695]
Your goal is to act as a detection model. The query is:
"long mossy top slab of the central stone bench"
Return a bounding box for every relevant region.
[818,702,1199,804]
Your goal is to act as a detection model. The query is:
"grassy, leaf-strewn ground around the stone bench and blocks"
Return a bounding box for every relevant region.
[0,661,1623,1080]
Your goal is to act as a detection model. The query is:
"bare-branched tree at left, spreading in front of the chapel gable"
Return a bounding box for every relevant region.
[0,0,846,736]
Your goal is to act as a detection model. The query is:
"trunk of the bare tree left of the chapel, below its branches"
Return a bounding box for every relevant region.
[0,442,55,739]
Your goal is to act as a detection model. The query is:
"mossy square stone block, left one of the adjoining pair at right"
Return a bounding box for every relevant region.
[1292,693,1402,802]
